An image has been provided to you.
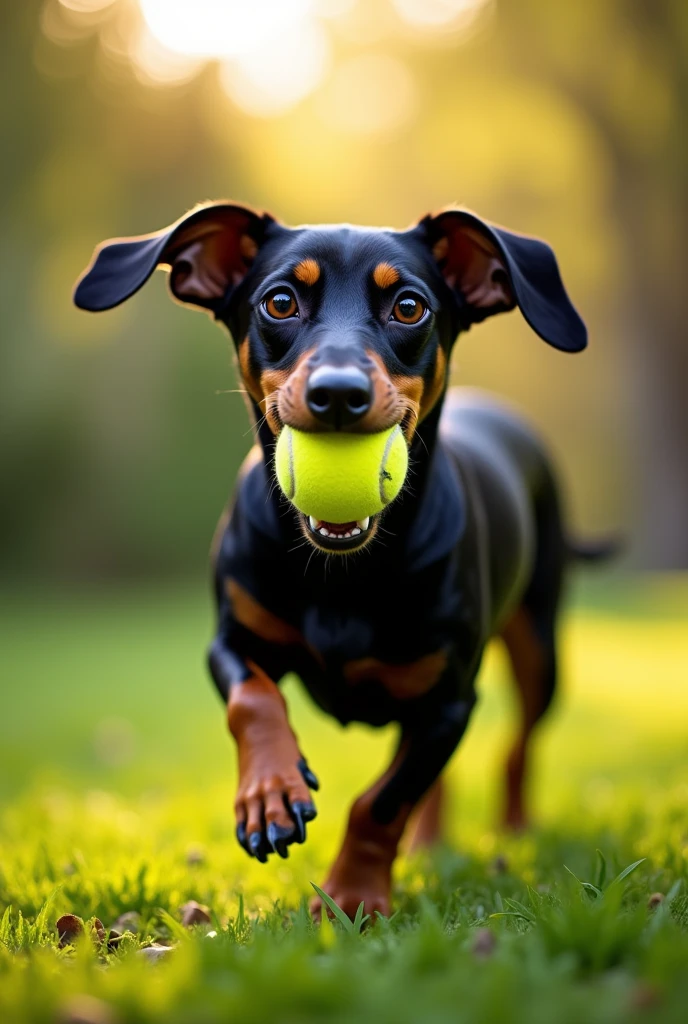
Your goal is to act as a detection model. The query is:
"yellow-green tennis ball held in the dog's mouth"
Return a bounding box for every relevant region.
[274,425,409,523]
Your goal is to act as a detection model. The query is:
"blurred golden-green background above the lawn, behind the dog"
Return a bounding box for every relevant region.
[5,0,688,581]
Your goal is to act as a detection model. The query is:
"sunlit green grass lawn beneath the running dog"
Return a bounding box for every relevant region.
[0,580,688,1024]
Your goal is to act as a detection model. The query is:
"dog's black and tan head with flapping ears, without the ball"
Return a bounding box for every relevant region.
[75,203,586,551]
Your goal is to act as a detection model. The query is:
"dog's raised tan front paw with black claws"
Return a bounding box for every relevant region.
[234,758,318,863]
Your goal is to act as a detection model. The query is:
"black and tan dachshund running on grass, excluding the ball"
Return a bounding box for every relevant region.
[75,203,602,914]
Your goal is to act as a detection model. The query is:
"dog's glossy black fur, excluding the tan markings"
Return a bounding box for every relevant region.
[75,206,586,847]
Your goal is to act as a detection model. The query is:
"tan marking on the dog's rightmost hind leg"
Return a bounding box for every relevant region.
[501,607,546,828]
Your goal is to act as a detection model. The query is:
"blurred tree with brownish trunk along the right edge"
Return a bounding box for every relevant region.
[499,0,688,569]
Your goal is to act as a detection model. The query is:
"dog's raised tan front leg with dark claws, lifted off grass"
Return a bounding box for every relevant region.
[210,642,318,863]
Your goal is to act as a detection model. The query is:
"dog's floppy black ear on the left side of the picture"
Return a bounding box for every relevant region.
[74,203,273,312]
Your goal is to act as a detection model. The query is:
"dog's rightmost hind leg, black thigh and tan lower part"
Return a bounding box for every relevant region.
[501,478,568,828]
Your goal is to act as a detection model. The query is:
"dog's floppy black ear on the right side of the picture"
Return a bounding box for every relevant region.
[420,210,588,352]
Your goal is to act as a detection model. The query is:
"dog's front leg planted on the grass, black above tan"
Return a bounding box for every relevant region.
[311,699,474,918]
